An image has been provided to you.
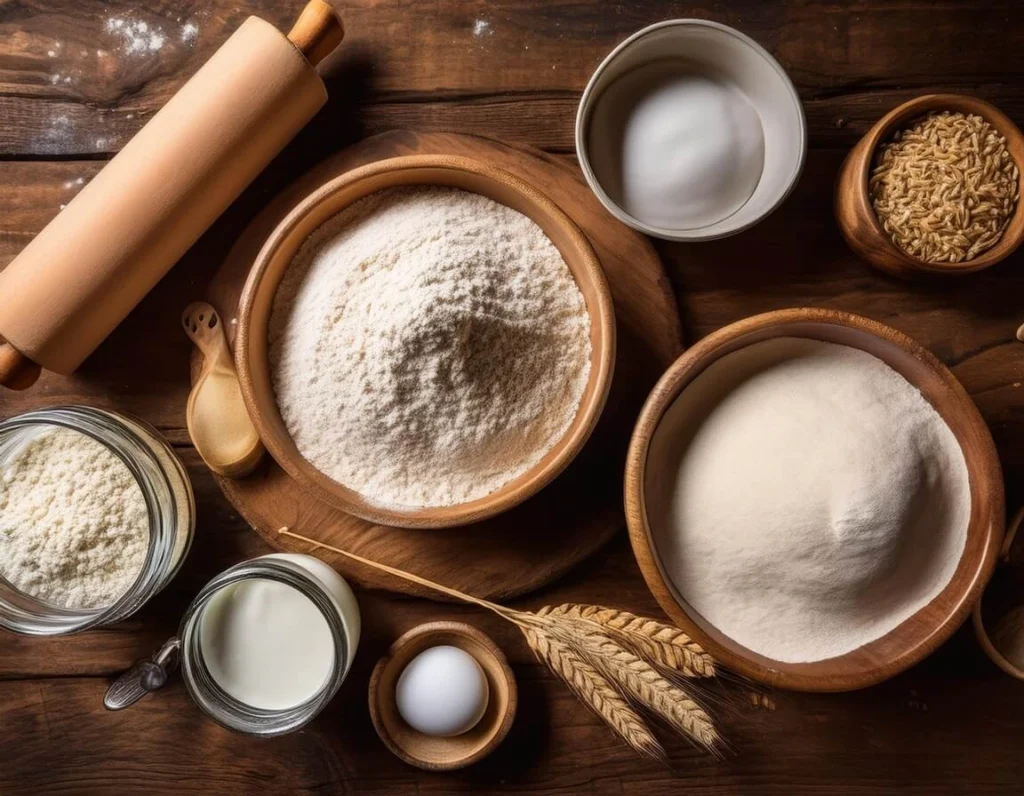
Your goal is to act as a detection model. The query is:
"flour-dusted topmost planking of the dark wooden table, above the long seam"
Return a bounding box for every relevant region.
[6,0,1024,158]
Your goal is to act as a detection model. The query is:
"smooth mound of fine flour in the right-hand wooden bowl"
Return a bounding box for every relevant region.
[646,338,971,663]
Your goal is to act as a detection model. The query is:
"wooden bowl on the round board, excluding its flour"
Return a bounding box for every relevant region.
[234,155,615,528]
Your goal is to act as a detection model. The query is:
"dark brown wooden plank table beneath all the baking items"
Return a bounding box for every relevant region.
[0,0,1024,796]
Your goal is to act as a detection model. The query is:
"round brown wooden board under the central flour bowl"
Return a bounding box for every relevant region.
[193,131,683,599]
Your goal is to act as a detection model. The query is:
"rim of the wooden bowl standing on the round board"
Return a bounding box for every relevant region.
[234,155,616,529]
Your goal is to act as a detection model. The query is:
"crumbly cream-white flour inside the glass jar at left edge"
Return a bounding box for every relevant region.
[0,427,150,609]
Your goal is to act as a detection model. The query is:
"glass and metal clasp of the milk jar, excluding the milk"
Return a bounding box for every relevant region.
[103,553,360,737]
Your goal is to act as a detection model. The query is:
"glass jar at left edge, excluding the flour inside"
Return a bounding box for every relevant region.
[0,406,196,635]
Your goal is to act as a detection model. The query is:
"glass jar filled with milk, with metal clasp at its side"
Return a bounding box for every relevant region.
[104,553,359,736]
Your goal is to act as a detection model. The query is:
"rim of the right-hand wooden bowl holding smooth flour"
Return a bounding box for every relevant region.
[624,307,1006,692]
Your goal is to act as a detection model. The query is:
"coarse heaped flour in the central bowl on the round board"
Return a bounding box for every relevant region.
[268,187,591,506]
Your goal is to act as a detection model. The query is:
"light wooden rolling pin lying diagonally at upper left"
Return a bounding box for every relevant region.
[0,0,344,389]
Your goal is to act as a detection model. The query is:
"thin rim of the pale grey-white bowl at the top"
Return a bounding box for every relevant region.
[575,17,808,243]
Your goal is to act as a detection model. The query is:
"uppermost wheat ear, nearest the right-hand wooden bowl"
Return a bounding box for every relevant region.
[537,602,715,677]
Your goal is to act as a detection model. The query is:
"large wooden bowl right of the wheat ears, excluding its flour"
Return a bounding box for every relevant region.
[626,309,1005,692]
